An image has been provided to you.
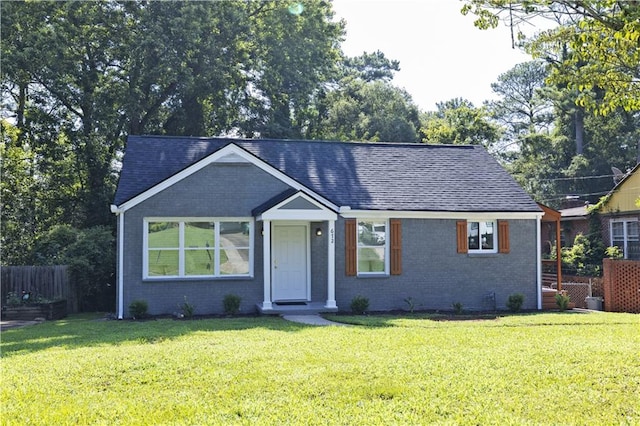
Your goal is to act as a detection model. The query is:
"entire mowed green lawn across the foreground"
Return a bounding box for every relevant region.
[0,312,640,425]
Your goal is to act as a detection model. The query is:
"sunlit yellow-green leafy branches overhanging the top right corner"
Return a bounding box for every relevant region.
[462,0,640,114]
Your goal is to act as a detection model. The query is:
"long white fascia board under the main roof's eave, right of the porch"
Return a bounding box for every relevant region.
[340,210,544,220]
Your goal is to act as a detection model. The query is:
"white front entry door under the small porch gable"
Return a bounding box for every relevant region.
[271,225,308,302]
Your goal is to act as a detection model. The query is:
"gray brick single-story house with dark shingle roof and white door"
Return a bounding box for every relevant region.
[112,136,542,318]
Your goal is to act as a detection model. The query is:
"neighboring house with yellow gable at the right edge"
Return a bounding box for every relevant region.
[598,163,640,260]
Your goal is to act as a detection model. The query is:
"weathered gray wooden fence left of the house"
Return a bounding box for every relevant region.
[0,265,78,312]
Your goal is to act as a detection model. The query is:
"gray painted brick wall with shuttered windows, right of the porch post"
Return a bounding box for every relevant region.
[336,219,537,310]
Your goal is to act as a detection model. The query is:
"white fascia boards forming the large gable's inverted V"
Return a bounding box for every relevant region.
[112,143,338,211]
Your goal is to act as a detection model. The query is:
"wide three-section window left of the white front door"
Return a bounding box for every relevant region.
[143,218,253,278]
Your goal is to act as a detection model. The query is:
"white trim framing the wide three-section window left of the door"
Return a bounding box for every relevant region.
[142,217,255,281]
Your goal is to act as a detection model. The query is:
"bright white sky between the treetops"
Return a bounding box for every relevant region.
[333,0,531,111]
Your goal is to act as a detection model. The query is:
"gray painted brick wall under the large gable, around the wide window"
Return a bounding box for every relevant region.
[123,164,288,316]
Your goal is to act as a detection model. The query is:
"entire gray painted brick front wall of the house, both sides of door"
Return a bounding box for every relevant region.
[116,164,537,316]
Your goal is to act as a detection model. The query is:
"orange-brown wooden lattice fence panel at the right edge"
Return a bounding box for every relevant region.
[603,259,640,313]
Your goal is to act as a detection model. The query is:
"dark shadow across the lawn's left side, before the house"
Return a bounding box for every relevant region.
[0,314,311,358]
